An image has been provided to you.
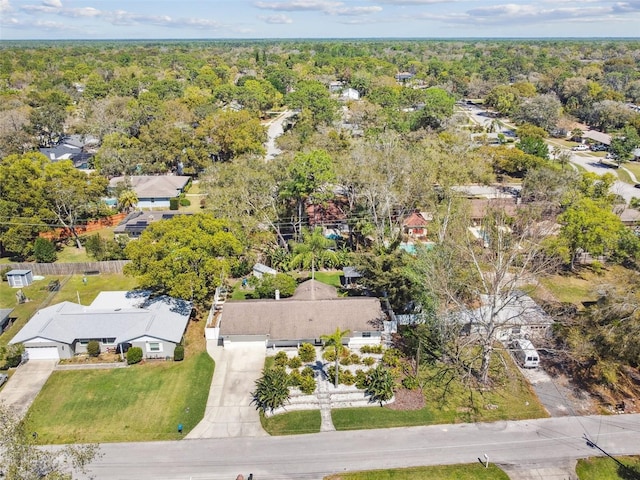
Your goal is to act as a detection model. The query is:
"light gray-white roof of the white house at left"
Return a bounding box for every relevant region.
[9,292,191,344]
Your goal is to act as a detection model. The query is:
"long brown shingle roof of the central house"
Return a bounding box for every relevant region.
[220,281,385,340]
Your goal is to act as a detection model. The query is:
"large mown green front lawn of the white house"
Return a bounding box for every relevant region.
[27,352,214,444]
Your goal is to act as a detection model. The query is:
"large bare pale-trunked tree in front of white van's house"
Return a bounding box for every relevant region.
[411,209,552,385]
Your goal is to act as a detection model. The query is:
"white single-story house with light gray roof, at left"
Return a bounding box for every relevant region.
[9,291,192,360]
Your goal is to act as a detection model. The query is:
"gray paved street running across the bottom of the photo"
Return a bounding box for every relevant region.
[82,414,640,480]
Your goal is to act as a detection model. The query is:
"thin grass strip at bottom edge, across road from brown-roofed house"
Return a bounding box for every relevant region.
[324,463,509,480]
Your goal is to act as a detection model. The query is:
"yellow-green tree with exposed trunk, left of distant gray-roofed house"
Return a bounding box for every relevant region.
[44,160,107,248]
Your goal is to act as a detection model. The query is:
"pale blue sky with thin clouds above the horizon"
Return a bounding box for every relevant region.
[0,0,640,40]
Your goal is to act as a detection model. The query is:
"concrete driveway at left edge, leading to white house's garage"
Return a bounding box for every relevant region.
[0,360,56,416]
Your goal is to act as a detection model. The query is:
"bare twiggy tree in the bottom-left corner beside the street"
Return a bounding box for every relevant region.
[0,405,100,480]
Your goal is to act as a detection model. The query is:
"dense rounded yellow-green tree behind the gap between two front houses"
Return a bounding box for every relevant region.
[124,214,244,303]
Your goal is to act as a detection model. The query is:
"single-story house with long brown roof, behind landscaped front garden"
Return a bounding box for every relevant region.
[215,280,386,347]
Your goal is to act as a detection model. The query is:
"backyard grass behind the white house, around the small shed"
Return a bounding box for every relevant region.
[0,274,137,346]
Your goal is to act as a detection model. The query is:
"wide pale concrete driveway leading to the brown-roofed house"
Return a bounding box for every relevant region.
[186,341,267,438]
